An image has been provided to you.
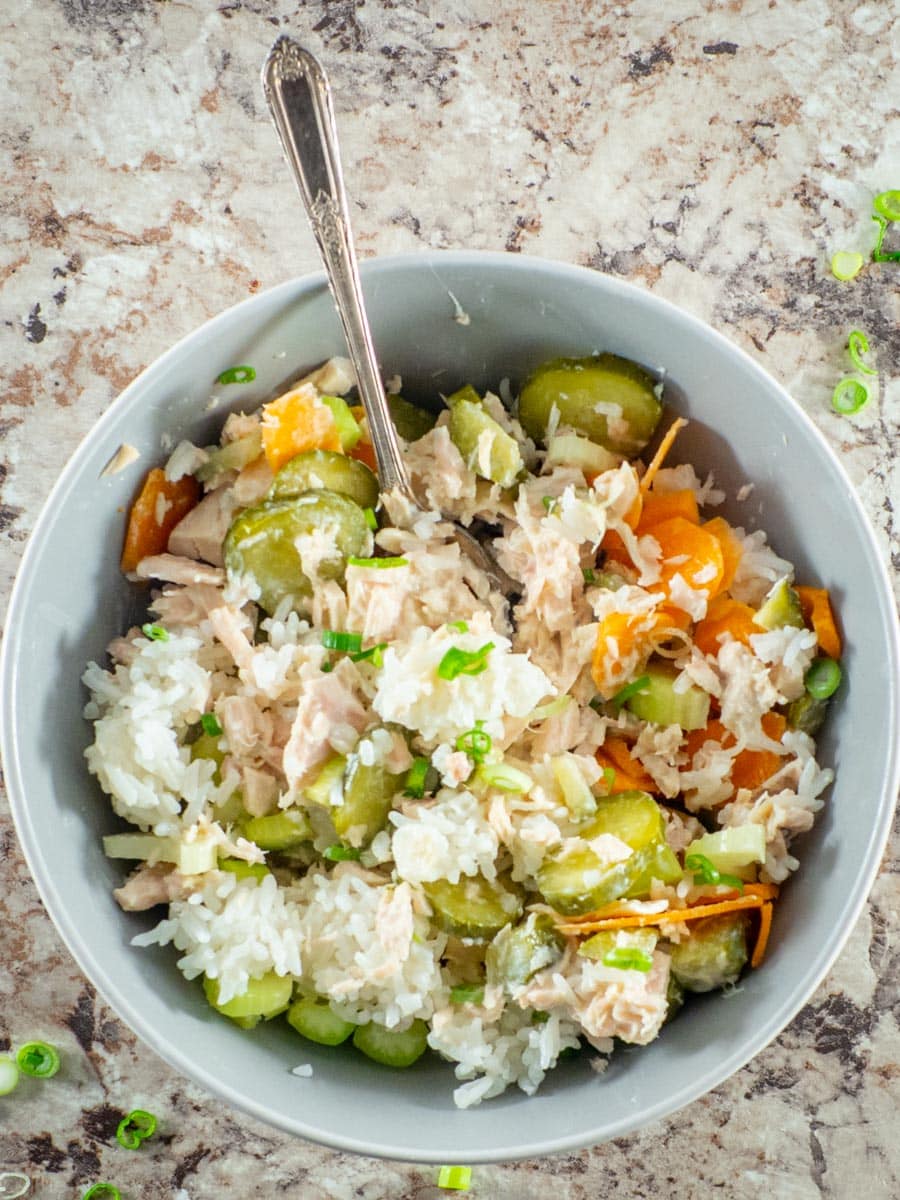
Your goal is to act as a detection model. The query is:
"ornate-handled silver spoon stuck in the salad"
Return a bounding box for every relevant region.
[263,37,522,596]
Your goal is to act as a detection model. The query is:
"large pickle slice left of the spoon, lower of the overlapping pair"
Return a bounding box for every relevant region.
[224,491,370,613]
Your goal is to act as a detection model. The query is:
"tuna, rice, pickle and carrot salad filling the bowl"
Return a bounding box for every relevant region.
[84,354,841,1108]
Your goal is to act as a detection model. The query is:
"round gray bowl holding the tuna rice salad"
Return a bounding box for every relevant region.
[2,253,899,1163]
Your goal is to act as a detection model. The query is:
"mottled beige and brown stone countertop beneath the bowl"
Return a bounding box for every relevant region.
[0,0,900,1200]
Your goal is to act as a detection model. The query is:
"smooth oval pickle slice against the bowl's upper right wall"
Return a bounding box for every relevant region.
[518,354,662,456]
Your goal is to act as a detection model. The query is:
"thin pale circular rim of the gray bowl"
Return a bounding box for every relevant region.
[0,250,900,1164]
